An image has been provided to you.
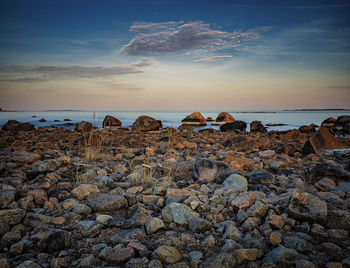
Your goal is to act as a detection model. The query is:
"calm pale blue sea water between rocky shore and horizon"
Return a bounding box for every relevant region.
[0,111,350,130]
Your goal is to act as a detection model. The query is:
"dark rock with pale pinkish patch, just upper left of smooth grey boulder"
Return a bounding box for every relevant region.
[193,158,230,182]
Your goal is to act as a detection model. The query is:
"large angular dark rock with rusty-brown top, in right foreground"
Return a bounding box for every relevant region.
[288,191,327,223]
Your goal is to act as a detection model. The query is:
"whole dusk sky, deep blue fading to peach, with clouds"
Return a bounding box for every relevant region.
[0,0,350,111]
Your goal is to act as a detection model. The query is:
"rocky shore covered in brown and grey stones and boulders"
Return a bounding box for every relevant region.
[0,113,350,268]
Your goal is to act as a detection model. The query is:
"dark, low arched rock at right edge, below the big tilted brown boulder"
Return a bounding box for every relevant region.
[303,163,350,183]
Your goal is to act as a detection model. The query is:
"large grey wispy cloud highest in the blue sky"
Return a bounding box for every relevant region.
[120,21,269,55]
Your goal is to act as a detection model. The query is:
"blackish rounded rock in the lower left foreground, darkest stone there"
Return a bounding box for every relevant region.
[39,230,73,253]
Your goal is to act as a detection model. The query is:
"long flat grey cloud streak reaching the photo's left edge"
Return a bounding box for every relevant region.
[0,59,156,83]
